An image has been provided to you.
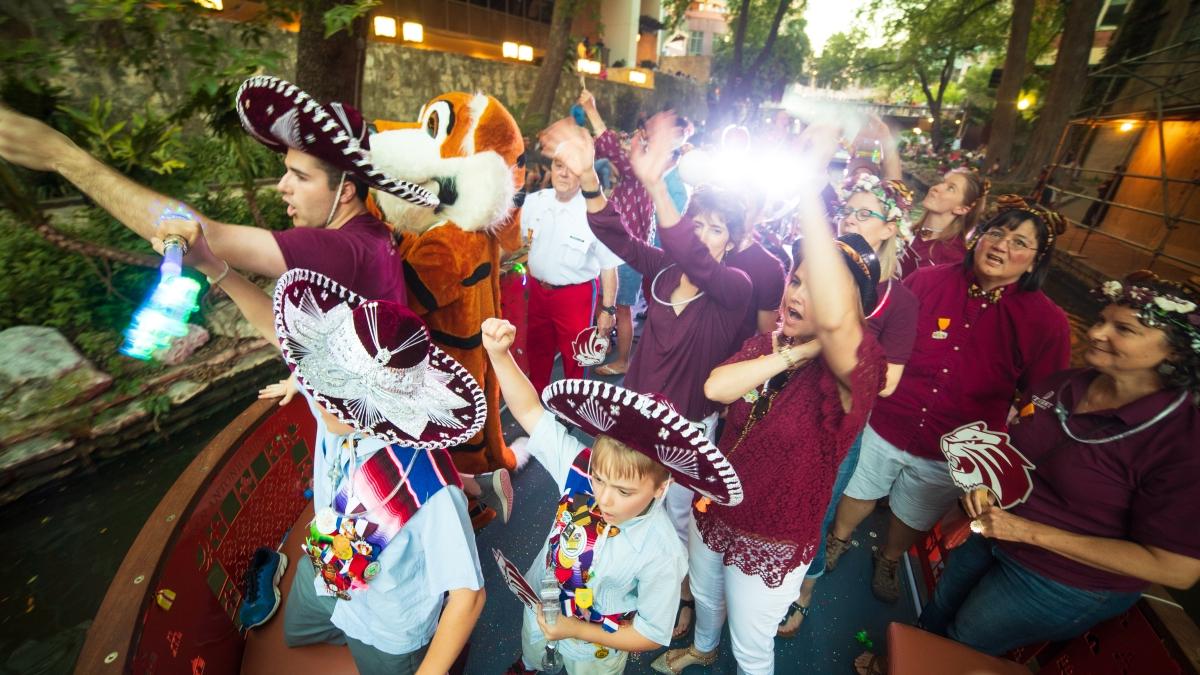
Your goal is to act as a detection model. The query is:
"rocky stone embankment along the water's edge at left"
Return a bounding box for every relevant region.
[0,303,287,506]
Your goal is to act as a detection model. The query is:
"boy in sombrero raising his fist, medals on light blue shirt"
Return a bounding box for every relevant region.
[482,318,742,675]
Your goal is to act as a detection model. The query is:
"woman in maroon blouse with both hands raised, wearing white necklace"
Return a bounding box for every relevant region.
[542,113,751,547]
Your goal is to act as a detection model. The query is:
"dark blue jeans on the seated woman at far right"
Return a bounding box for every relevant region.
[919,534,1141,656]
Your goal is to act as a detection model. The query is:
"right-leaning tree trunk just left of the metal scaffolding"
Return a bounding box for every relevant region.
[1013,0,1104,183]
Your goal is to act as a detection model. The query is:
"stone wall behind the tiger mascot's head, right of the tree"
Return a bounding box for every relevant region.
[362,43,708,131]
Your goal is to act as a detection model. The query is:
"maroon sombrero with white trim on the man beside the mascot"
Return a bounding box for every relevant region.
[236,74,438,208]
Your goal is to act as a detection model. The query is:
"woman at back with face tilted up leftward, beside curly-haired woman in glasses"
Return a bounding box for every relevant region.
[900,168,991,276]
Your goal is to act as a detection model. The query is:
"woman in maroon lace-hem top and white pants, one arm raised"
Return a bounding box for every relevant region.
[653,127,883,674]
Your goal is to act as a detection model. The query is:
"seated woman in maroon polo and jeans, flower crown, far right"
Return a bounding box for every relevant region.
[920,271,1200,655]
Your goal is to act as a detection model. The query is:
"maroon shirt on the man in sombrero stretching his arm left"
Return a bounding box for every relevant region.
[274,214,408,306]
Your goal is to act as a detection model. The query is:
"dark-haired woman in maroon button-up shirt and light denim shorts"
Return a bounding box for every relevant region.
[826,195,1070,602]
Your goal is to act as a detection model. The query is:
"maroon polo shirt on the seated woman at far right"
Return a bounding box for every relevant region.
[1000,369,1200,592]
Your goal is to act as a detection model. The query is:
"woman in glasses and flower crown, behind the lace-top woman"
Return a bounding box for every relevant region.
[776,173,920,638]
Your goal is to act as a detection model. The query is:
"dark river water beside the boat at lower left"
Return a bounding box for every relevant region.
[0,388,253,674]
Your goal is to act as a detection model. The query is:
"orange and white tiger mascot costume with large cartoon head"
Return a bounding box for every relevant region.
[371,92,524,494]
